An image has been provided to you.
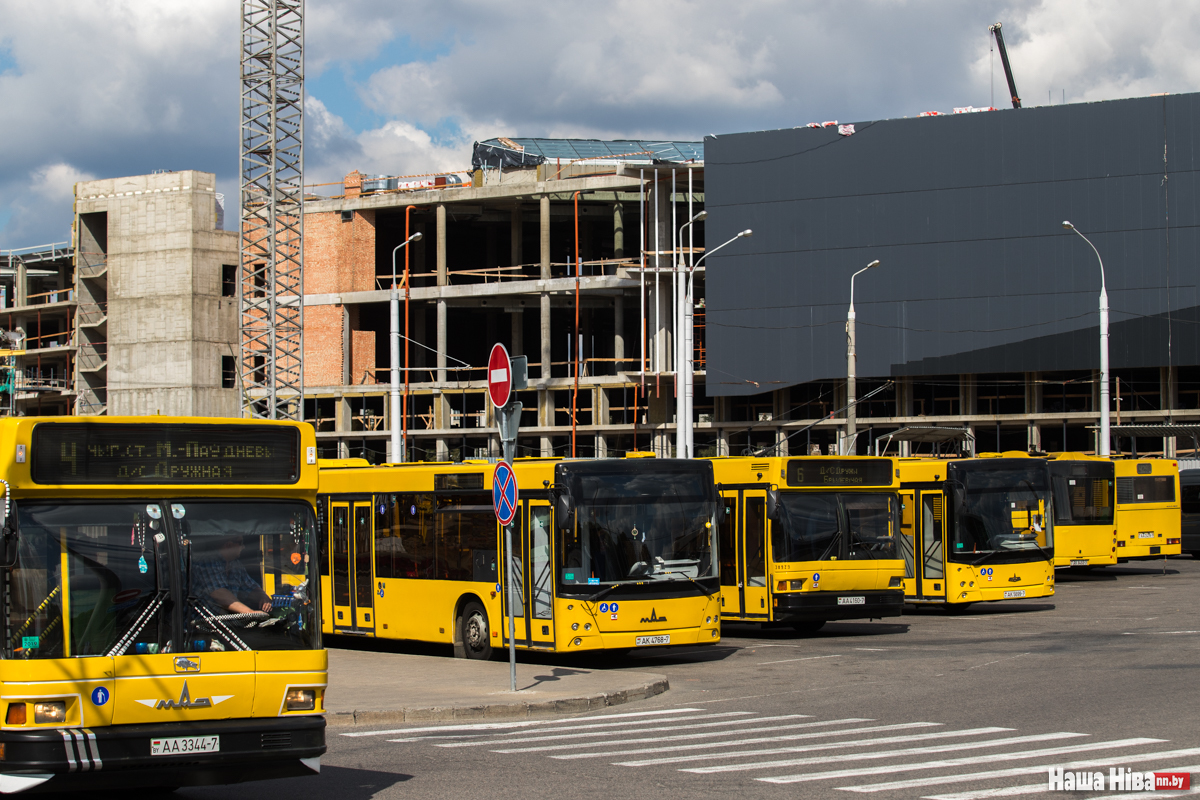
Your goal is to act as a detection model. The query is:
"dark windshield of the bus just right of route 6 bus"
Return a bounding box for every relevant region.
[947,459,1054,564]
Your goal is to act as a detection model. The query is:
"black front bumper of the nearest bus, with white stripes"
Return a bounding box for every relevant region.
[0,716,325,794]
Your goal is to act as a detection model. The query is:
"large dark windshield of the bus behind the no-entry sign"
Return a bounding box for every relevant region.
[558,459,716,590]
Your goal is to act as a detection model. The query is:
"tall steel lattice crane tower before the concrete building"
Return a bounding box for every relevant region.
[238,0,304,420]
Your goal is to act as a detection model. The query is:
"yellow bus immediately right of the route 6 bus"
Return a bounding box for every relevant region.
[896,452,1055,609]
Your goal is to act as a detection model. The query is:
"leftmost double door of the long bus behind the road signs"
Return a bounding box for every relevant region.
[329,500,374,632]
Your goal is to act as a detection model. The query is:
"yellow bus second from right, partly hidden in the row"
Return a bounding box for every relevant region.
[1048,452,1117,569]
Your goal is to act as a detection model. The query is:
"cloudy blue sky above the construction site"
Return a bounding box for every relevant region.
[0,0,1200,248]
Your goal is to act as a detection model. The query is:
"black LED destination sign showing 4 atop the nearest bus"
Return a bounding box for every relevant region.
[30,422,300,485]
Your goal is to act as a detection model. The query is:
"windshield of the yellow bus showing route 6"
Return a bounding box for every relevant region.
[770,492,896,564]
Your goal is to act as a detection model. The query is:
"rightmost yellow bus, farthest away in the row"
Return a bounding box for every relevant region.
[1112,458,1183,561]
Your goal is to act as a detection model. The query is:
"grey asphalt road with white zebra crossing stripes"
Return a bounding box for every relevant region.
[179,558,1200,800]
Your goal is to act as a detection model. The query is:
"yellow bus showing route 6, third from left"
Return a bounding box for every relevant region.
[712,456,904,632]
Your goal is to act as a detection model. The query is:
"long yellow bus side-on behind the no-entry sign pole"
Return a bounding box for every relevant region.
[318,458,720,658]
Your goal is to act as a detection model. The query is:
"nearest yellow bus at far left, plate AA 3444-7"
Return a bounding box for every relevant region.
[0,416,326,793]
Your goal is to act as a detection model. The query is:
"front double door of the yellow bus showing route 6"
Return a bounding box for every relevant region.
[719,489,769,619]
